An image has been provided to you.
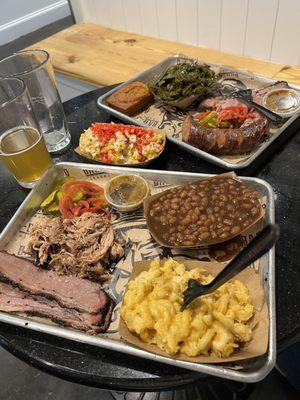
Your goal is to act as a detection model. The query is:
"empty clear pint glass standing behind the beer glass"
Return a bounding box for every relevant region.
[0,50,71,153]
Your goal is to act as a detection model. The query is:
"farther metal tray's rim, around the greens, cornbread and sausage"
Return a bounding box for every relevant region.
[97,55,300,170]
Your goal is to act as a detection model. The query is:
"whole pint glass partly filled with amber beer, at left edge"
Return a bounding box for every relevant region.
[0,78,52,188]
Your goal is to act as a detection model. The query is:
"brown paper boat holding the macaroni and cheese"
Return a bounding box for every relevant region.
[119,258,269,364]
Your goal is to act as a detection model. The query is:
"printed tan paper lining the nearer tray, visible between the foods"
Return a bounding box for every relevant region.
[3,165,266,346]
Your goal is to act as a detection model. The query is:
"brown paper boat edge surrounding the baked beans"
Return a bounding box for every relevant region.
[144,172,265,249]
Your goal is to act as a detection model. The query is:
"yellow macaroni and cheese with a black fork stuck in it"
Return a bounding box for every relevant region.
[121,259,254,357]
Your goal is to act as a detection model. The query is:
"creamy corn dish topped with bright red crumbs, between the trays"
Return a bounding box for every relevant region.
[79,123,165,164]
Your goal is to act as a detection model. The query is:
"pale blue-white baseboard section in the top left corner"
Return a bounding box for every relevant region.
[0,0,70,44]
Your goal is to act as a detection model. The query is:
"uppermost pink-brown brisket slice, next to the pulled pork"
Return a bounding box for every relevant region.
[0,252,109,313]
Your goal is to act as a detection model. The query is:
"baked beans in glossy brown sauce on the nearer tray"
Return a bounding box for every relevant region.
[144,175,264,248]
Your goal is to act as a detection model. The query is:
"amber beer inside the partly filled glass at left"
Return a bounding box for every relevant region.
[0,126,52,188]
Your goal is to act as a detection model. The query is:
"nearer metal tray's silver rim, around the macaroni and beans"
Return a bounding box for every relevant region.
[0,162,276,382]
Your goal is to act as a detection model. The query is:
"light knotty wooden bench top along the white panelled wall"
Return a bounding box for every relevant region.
[30,24,300,87]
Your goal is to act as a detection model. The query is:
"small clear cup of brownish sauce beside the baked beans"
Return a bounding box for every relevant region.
[104,174,150,211]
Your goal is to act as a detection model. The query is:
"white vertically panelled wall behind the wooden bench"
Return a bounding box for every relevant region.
[71,0,300,65]
